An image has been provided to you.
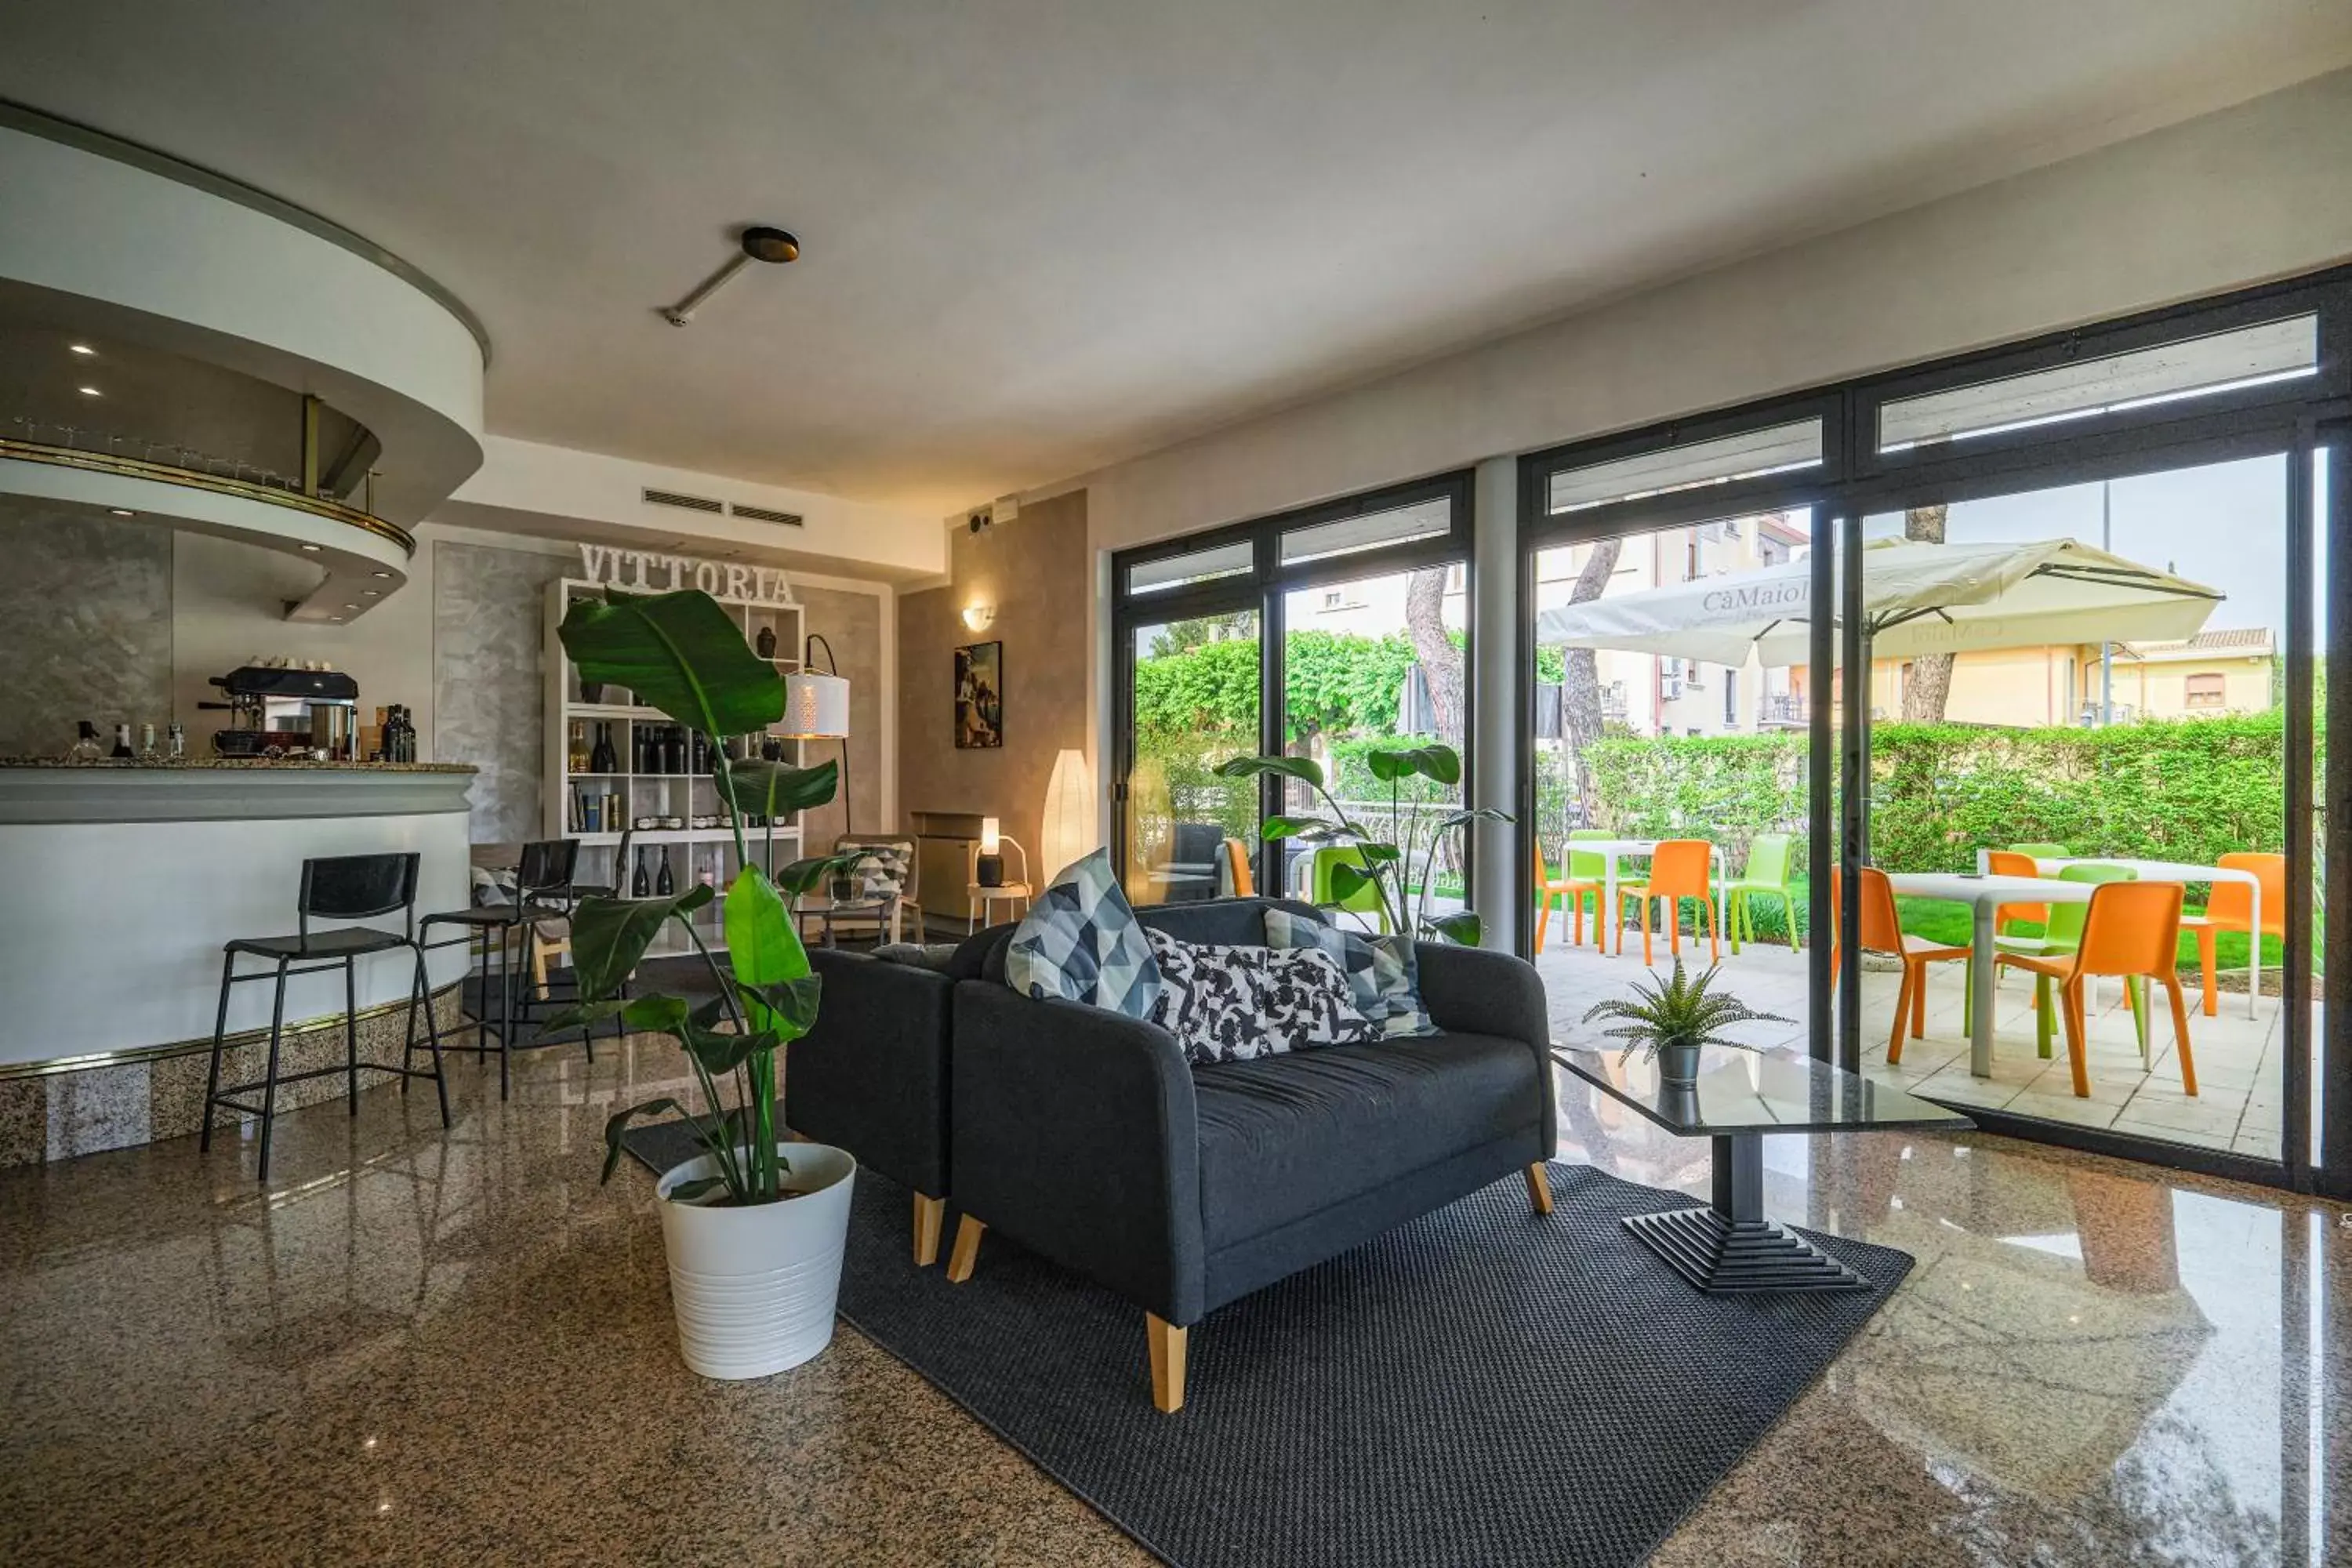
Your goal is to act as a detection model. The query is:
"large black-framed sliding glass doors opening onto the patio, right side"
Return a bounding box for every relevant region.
[1519,273,2352,1192]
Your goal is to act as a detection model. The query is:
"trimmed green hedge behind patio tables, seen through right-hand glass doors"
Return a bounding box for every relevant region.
[1588,713,2286,869]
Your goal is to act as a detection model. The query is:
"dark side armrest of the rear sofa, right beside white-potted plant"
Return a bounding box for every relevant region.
[783,947,955,1196]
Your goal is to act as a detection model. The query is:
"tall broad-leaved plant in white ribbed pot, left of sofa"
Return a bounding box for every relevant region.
[543,590,856,1377]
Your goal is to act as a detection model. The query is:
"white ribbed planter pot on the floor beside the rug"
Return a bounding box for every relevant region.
[654,1142,858,1377]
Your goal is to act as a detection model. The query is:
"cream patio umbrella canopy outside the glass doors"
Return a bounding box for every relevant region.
[1536,539,2223,668]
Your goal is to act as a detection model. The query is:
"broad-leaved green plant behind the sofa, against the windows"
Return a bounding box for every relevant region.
[1216,746,1512,947]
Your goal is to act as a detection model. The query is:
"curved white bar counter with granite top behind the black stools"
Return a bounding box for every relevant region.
[0,757,475,1076]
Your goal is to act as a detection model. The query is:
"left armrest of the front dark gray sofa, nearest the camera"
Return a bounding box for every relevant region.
[950,980,1204,1323]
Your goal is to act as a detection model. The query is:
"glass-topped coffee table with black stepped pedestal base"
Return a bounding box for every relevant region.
[1552,1046,1976,1295]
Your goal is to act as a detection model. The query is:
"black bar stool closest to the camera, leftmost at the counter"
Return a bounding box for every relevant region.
[198,853,449,1180]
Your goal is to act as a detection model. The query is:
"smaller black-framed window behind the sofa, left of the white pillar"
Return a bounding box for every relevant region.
[1115,475,1470,924]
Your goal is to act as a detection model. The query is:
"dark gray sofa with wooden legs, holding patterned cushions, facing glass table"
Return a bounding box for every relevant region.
[946,898,1557,1410]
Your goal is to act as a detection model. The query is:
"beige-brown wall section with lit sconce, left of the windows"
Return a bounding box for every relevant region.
[898,492,1094,916]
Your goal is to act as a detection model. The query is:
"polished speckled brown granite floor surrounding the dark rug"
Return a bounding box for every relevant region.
[0,1041,2352,1568]
